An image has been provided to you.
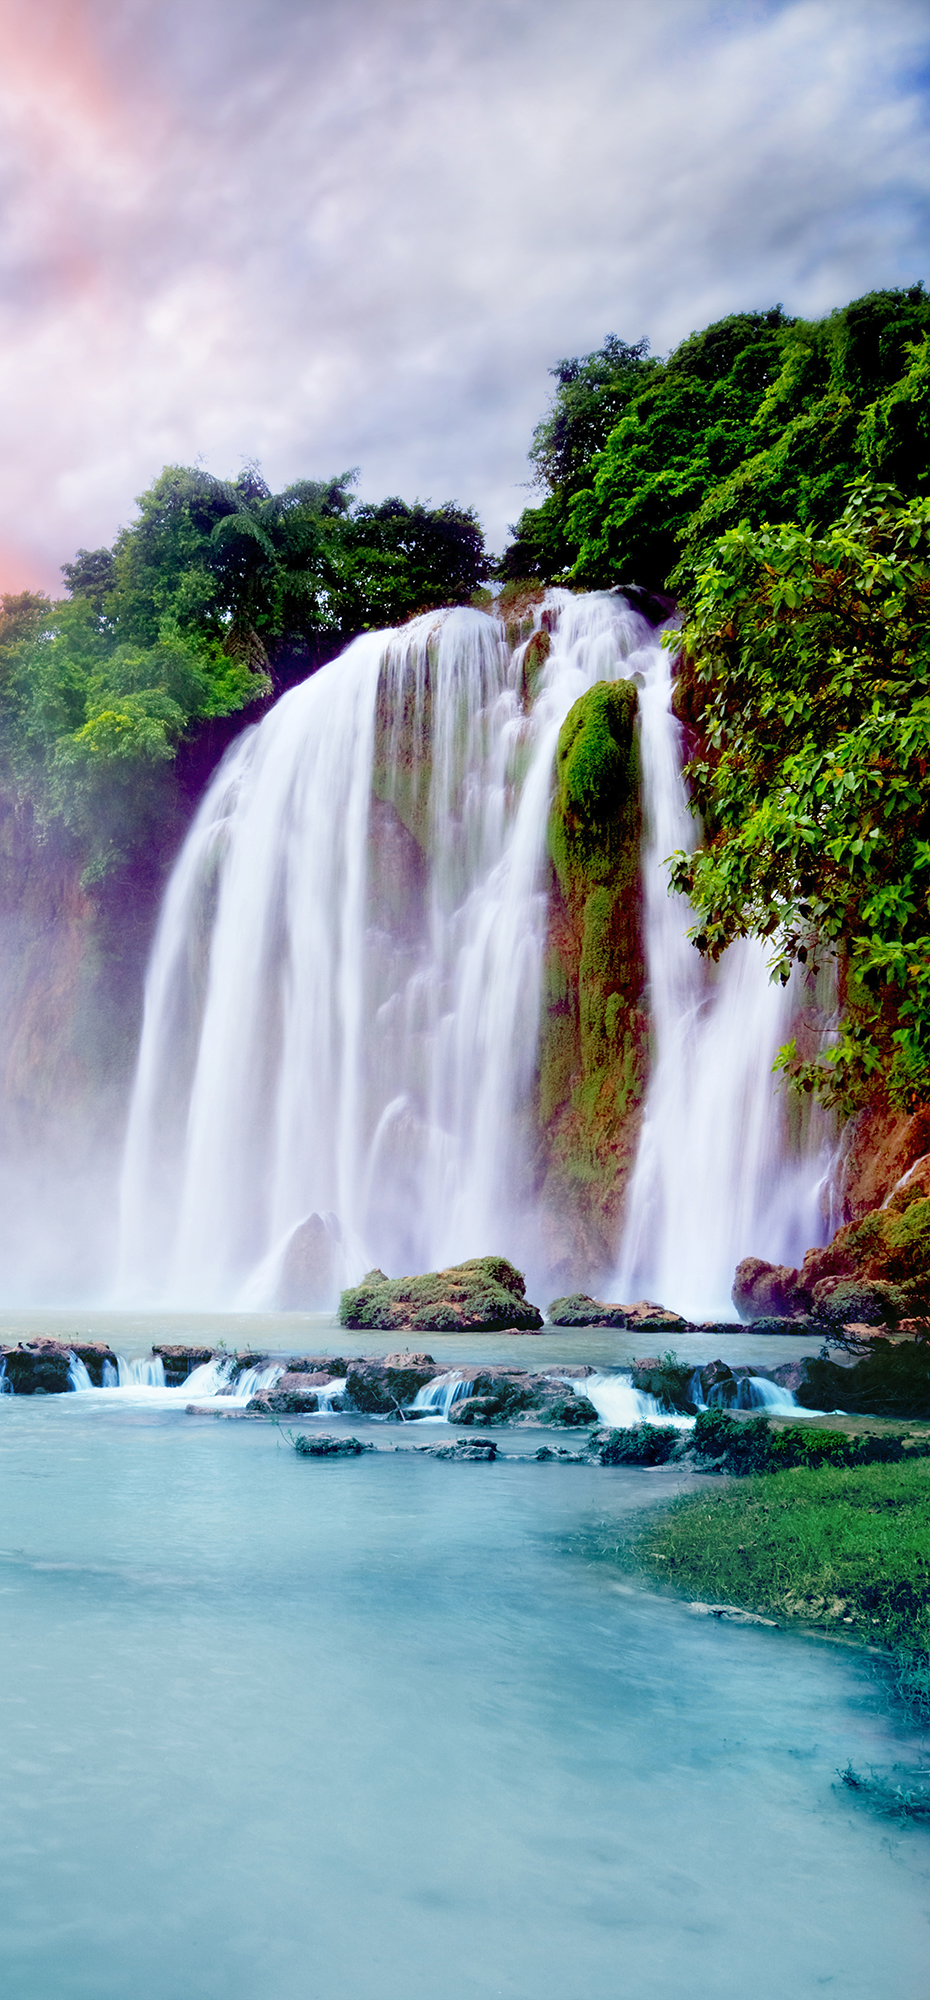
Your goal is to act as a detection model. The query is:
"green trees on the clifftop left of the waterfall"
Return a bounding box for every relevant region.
[0,466,488,882]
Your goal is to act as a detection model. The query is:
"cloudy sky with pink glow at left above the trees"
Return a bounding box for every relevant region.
[0,0,930,594]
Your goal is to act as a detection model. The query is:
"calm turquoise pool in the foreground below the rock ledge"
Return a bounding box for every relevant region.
[0,1392,928,2000]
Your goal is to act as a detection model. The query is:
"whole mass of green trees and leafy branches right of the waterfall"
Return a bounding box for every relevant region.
[502,284,930,1110]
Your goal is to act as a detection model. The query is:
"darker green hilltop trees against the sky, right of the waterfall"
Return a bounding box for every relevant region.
[500,284,930,594]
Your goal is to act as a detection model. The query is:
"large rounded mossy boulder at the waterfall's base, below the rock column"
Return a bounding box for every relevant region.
[340,1256,542,1334]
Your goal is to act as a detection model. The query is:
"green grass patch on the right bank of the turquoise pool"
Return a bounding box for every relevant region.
[634,1458,930,1656]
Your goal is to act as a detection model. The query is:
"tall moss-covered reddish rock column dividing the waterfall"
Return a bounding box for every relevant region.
[536,680,648,1288]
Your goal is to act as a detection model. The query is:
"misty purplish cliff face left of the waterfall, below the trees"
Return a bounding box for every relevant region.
[0,794,180,1300]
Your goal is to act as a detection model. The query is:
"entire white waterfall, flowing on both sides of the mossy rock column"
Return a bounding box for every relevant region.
[118,592,828,1310]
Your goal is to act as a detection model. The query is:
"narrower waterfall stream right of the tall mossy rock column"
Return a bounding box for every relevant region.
[614,624,828,1318]
